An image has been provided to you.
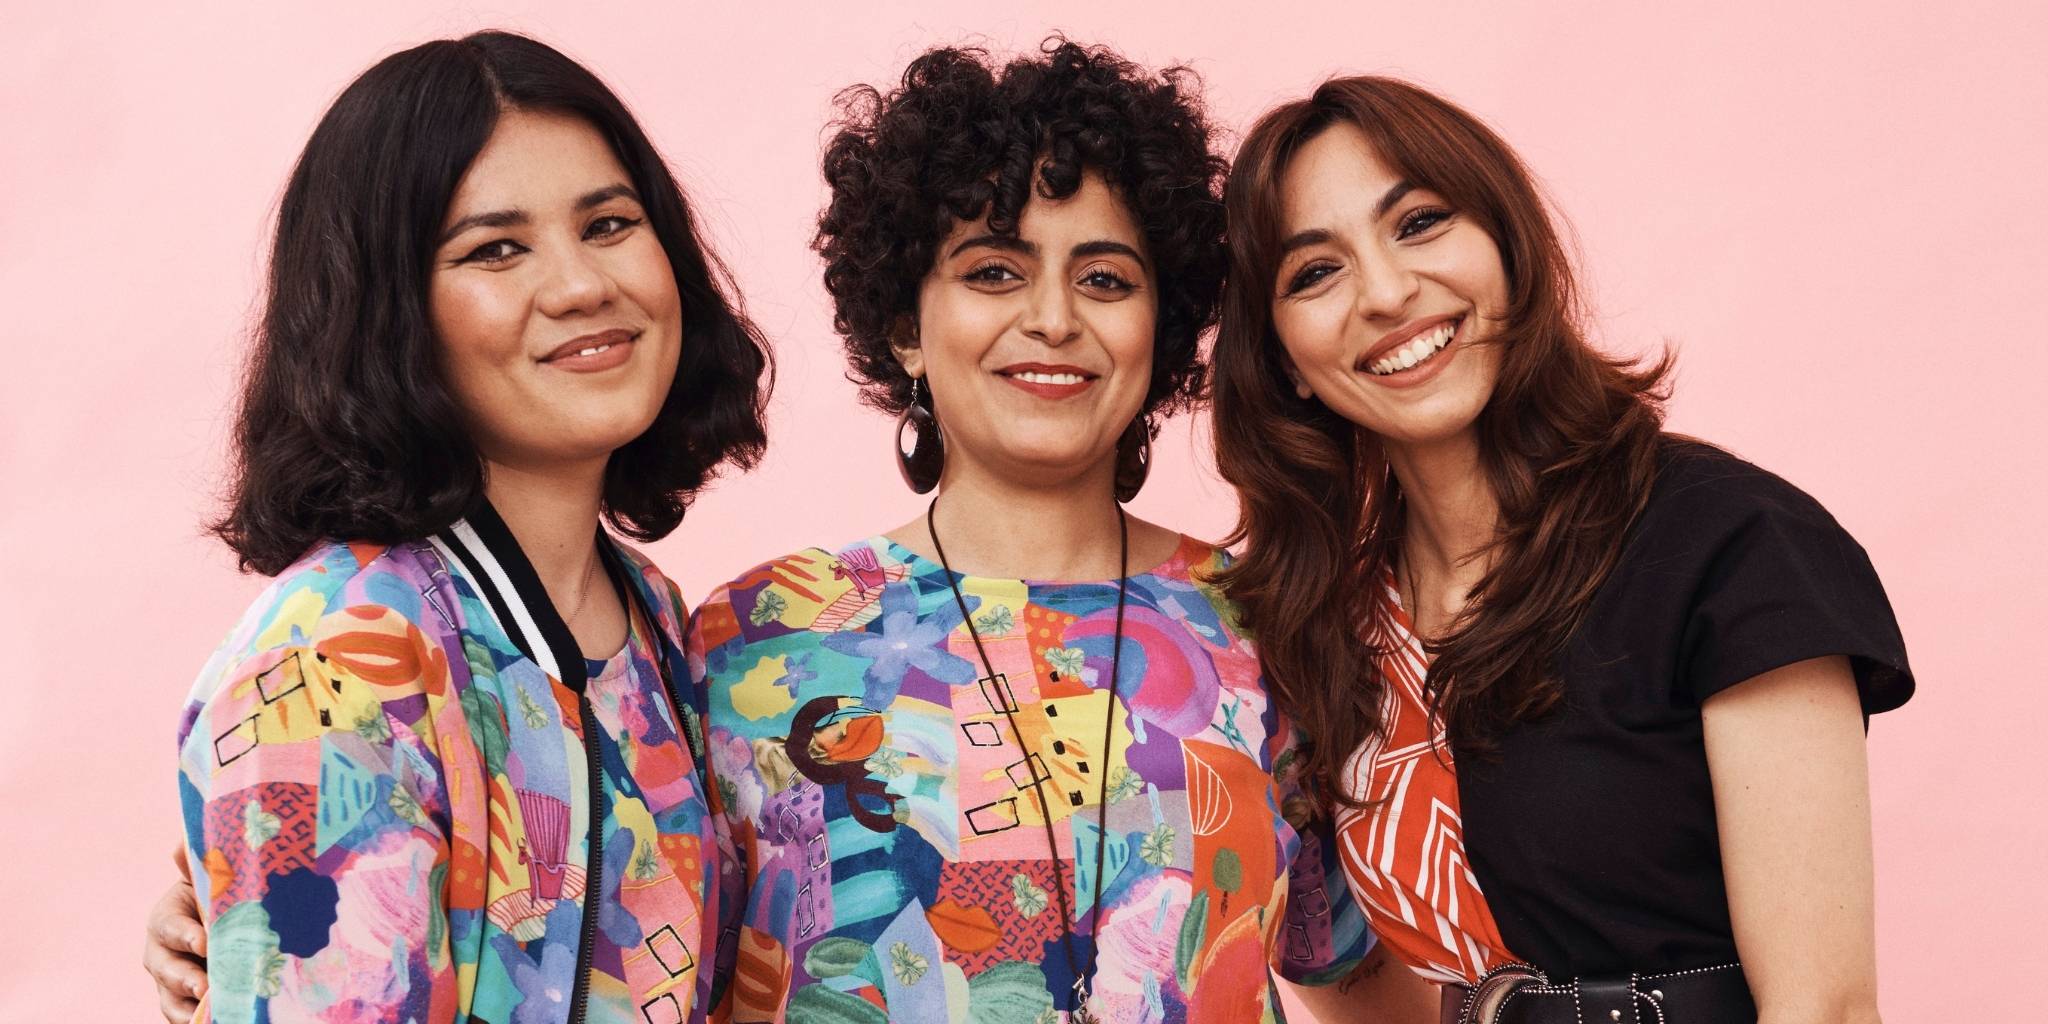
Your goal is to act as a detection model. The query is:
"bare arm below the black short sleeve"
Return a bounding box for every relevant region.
[1702,655,1878,1024]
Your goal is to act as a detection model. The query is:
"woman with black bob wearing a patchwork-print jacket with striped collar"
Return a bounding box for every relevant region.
[152,33,768,1022]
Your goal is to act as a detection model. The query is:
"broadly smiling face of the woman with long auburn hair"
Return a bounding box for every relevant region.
[1272,123,1507,446]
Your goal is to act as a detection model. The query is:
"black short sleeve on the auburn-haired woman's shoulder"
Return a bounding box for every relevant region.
[1681,469,1913,715]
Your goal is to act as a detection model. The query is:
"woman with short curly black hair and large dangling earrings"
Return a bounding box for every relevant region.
[690,39,1370,1024]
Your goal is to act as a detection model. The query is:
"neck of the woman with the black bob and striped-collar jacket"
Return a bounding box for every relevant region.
[483,463,604,598]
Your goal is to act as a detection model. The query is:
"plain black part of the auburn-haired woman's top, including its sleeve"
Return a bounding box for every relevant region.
[1458,438,1913,979]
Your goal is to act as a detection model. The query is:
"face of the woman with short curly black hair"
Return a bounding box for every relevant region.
[897,172,1157,491]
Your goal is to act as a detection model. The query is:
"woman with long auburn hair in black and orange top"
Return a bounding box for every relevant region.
[1214,78,1913,1022]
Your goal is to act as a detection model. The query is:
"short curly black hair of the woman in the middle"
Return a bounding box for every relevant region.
[813,35,1229,422]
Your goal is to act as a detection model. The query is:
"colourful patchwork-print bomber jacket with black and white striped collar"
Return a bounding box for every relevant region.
[180,508,717,1024]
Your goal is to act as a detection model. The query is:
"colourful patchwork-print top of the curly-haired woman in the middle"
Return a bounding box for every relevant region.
[690,539,1372,1024]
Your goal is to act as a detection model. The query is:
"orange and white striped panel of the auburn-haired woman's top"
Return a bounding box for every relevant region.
[1337,582,1513,983]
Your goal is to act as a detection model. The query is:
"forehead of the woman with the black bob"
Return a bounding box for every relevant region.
[449,109,631,211]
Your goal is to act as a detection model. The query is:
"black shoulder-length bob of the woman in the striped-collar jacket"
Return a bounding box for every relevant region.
[213,33,772,575]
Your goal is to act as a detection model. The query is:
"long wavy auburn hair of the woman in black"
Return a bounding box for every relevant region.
[1214,76,1671,811]
